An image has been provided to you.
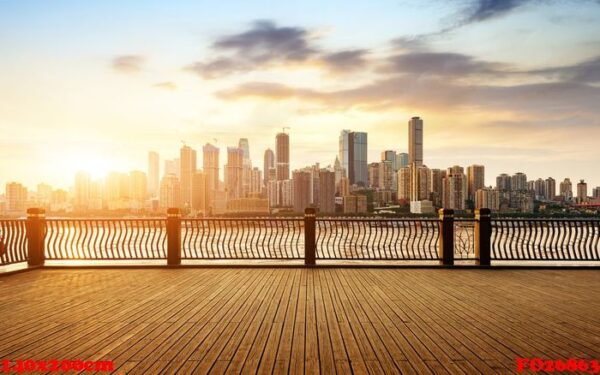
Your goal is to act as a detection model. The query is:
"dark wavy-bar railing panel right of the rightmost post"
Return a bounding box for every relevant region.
[491,219,600,261]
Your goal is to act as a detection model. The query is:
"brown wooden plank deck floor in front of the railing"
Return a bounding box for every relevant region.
[0,268,600,374]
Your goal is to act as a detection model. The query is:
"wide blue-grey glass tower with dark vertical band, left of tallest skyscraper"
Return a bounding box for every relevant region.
[339,130,369,186]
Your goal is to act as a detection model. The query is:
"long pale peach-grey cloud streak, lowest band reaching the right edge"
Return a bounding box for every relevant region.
[218,75,600,118]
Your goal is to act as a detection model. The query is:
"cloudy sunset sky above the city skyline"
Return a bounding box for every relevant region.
[0,0,600,191]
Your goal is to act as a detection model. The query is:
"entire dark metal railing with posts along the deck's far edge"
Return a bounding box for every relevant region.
[0,209,600,270]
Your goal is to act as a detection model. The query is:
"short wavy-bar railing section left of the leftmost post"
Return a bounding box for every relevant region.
[0,220,27,265]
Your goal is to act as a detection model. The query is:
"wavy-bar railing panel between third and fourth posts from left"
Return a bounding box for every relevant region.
[316,219,440,260]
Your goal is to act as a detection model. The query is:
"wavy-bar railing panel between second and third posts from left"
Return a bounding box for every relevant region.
[181,218,304,259]
